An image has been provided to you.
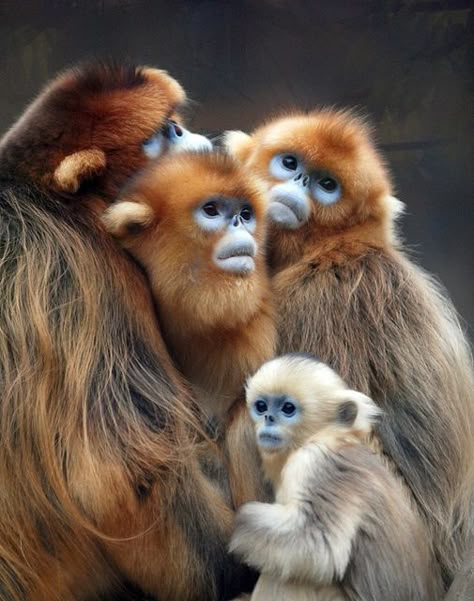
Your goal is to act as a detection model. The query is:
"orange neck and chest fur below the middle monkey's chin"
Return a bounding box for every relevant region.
[156,265,276,419]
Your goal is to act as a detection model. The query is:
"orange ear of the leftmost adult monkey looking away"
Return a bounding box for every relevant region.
[53,148,107,194]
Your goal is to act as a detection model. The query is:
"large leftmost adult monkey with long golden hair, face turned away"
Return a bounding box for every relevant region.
[0,64,248,601]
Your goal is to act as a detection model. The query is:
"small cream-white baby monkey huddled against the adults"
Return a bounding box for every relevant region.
[230,354,441,601]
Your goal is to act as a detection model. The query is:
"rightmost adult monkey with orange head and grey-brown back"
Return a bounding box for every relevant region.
[227,110,474,583]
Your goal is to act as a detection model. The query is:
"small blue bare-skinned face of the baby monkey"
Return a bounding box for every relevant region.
[250,395,301,451]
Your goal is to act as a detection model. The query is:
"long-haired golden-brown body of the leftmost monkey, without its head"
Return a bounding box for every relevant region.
[0,181,244,601]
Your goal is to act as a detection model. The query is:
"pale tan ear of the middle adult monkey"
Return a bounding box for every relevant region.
[101,200,155,240]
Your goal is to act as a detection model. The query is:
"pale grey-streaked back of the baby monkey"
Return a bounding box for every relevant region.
[299,444,442,601]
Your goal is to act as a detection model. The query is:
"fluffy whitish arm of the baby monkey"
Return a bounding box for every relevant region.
[230,501,356,585]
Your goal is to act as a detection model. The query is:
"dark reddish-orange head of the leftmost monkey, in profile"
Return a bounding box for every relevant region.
[0,62,211,200]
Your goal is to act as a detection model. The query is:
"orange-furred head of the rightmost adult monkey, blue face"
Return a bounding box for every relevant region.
[225,110,401,262]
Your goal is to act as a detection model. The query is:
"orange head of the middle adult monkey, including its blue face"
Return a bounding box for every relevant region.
[103,152,266,326]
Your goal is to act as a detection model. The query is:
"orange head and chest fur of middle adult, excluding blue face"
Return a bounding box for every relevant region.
[104,153,274,417]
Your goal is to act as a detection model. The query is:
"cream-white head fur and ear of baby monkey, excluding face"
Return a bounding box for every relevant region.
[246,354,382,446]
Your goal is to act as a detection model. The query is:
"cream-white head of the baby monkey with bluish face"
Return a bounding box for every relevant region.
[246,354,380,453]
